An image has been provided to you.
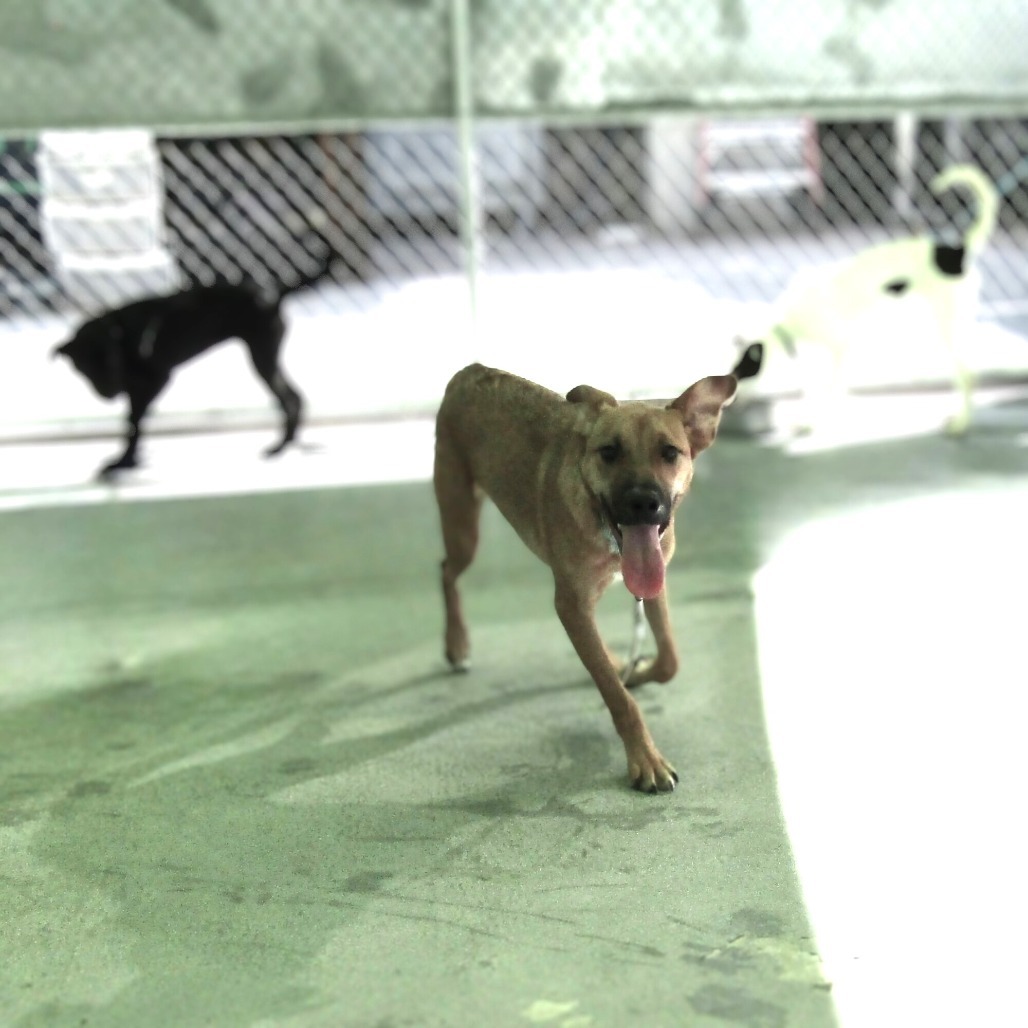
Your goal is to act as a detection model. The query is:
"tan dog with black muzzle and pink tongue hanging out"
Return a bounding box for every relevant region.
[435,364,737,793]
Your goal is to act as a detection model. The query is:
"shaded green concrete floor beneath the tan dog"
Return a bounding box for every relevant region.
[0,396,1028,1028]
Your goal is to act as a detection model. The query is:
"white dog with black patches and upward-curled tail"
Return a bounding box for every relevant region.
[733,164,999,435]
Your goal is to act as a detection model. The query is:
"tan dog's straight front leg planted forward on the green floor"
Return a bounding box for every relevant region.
[555,579,678,793]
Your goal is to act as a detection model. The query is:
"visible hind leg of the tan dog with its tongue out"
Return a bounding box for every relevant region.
[433,427,484,671]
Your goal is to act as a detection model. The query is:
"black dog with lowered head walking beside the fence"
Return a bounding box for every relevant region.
[53,260,331,478]
